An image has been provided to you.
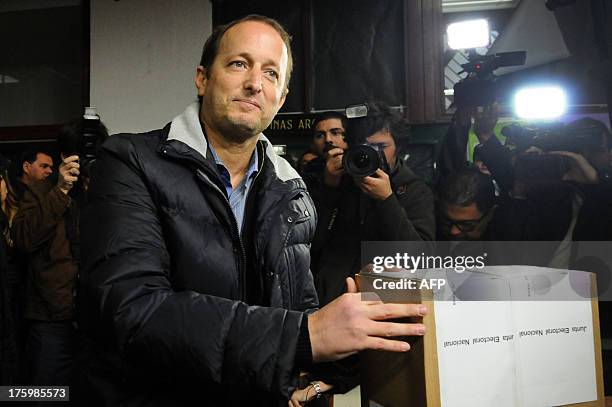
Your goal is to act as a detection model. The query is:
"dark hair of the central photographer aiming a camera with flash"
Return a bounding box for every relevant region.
[347,102,409,148]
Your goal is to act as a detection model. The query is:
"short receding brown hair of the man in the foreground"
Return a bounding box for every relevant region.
[200,14,293,98]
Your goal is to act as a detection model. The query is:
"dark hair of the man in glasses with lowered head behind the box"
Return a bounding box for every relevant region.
[438,167,495,214]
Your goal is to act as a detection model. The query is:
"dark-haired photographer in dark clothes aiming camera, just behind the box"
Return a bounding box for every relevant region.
[308,103,435,304]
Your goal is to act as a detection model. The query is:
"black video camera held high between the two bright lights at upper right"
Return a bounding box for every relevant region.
[453,51,527,109]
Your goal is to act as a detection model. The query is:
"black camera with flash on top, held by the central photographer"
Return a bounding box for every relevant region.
[342,103,390,178]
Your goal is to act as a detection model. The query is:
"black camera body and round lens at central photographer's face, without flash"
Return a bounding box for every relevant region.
[342,144,389,178]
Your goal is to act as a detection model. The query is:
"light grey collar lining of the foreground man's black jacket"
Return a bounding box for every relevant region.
[168,102,301,182]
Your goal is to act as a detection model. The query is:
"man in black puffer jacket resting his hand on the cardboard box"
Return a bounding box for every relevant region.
[79,16,426,406]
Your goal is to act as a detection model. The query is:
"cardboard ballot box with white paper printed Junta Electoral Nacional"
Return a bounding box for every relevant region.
[357,266,604,407]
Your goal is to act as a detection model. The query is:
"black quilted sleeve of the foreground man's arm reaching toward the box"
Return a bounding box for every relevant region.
[80,135,304,398]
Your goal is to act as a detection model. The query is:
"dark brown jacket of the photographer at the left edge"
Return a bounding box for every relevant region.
[12,181,78,321]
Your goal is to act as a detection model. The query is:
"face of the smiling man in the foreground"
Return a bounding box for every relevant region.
[195,21,288,142]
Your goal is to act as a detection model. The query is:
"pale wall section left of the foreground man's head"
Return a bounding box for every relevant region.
[90,0,212,134]
